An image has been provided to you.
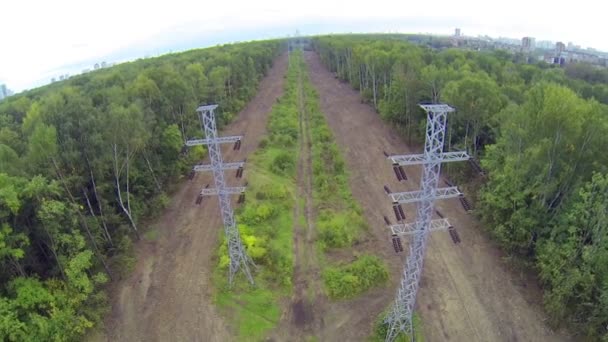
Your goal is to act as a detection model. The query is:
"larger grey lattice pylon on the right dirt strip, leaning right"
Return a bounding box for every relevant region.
[385,104,469,341]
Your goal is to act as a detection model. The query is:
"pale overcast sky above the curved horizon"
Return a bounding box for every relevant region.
[0,0,608,91]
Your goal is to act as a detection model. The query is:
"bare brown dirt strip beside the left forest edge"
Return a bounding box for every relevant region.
[96,56,287,342]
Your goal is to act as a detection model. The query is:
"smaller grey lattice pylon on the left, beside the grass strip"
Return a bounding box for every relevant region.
[186,105,255,285]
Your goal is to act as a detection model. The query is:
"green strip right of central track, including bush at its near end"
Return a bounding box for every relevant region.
[292,51,388,299]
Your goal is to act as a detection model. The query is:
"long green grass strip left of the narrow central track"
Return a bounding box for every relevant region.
[214,50,301,341]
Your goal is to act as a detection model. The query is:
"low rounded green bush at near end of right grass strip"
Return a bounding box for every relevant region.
[323,255,388,299]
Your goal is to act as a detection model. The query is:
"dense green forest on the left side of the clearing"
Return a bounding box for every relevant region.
[0,41,282,341]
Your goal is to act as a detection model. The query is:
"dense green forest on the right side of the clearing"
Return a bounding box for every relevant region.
[314,35,608,341]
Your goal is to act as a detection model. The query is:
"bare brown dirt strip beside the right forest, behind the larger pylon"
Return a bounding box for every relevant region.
[306,53,567,341]
